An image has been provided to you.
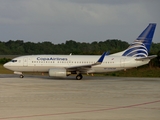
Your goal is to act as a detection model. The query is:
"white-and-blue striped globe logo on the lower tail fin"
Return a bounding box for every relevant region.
[122,41,148,57]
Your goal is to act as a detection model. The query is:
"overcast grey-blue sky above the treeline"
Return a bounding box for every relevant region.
[0,0,160,44]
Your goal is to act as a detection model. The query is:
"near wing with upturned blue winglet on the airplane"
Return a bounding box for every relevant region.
[66,52,108,73]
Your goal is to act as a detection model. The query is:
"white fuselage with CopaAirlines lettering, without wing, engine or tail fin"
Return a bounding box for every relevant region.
[4,55,150,73]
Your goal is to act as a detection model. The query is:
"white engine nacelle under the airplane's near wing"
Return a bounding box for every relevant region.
[49,68,67,78]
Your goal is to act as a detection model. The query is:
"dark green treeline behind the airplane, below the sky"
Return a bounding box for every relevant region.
[0,39,160,55]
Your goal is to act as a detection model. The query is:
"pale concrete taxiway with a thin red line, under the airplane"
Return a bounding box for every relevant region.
[0,75,160,120]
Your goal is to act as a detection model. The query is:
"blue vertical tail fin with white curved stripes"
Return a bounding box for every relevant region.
[122,23,156,57]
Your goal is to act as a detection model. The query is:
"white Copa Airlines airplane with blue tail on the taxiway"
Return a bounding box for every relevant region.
[4,23,157,80]
